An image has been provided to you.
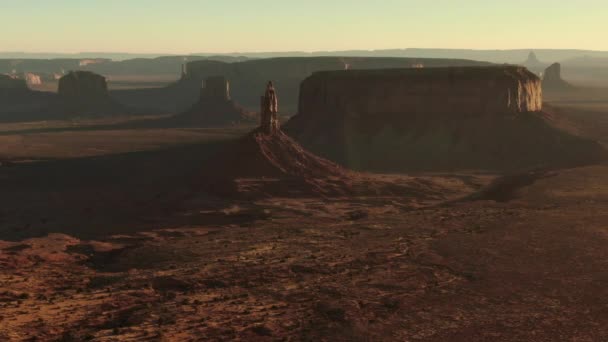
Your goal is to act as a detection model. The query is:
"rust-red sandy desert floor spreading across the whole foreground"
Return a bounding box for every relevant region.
[0,93,608,341]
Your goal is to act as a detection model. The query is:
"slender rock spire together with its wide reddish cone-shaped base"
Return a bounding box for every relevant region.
[203,82,355,197]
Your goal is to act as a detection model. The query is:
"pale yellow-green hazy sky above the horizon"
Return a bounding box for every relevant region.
[0,0,608,53]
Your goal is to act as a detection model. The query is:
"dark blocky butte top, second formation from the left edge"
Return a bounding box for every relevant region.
[58,71,110,103]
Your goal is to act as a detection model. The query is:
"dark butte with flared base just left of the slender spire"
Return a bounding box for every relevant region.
[171,76,254,126]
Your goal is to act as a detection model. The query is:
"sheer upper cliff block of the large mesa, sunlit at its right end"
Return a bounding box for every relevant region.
[298,66,542,118]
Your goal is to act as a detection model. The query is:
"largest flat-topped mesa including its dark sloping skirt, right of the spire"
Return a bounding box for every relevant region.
[284,66,603,172]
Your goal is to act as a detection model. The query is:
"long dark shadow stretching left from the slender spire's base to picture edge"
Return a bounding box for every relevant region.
[0,136,248,241]
